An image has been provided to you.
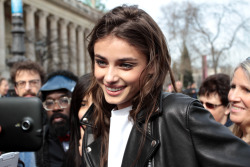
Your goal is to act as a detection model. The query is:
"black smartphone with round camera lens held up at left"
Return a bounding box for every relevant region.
[0,97,43,151]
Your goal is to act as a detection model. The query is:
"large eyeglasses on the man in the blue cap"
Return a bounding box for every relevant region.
[43,96,71,111]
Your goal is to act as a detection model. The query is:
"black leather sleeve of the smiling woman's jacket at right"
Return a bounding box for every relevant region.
[186,101,250,167]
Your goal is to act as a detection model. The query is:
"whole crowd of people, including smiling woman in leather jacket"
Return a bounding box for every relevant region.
[0,5,250,167]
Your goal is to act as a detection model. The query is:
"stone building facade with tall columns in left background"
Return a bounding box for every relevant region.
[0,0,103,78]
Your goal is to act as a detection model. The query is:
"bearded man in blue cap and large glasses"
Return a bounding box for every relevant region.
[37,70,78,167]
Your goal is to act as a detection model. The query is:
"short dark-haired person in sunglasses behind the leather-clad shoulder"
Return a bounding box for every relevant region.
[198,74,233,127]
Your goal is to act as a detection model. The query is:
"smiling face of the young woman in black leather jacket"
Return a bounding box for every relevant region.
[94,36,147,109]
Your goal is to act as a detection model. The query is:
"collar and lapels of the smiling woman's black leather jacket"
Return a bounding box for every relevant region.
[81,92,174,167]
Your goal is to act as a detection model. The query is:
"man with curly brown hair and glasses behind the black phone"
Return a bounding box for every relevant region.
[11,61,45,167]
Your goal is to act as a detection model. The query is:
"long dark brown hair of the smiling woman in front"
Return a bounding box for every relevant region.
[88,5,174,167]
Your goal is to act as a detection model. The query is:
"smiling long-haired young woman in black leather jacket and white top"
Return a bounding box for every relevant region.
[82,5,250,167]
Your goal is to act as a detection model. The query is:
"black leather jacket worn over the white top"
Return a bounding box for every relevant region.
[83,94,250,167]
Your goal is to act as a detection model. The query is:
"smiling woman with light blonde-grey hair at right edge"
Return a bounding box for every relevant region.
[228,57,250,144]
